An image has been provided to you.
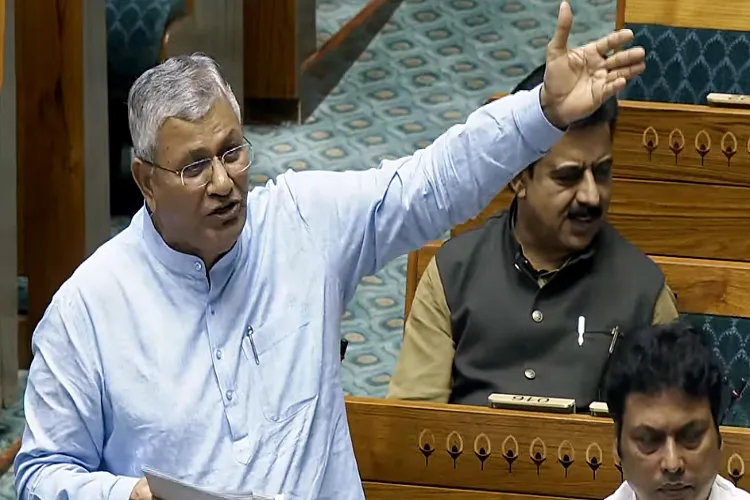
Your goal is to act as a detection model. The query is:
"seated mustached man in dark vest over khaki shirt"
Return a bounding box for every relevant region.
[388,66,678,408]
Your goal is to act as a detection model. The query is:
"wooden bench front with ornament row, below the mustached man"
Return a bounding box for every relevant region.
[346,397,750,500]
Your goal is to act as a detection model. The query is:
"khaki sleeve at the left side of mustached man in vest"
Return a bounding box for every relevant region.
[387,258,455,403]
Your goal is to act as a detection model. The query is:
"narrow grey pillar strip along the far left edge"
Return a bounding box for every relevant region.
[0,0,19,406]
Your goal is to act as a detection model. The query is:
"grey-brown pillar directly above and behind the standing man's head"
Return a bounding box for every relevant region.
[165,0,245,116]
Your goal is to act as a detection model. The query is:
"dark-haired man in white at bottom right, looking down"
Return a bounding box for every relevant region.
[606,322,750,500]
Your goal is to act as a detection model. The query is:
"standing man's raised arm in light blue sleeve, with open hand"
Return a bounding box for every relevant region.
[279,2,645,298]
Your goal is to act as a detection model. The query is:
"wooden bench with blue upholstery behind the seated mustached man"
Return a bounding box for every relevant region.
[405,97,750,427]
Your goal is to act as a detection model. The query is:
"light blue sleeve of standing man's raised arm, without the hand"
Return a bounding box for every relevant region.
[277,87,563,298]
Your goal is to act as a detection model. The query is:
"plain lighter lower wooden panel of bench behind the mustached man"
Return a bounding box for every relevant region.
[404,241,750,317]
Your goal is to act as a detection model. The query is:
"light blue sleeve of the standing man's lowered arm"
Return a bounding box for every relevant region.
[14,296,138,500]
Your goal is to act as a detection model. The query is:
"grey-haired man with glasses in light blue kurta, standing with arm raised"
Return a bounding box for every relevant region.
[15,2,645,500]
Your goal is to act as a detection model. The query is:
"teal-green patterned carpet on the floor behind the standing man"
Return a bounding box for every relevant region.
[0,0,615,494]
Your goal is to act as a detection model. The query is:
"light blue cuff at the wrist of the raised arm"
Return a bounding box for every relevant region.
[486,84,565,156]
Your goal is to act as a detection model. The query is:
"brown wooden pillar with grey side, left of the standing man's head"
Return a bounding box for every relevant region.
[15,0,110,367]
